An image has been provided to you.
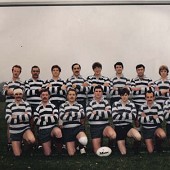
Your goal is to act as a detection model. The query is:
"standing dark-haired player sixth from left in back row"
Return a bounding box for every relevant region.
[110,62,130,107]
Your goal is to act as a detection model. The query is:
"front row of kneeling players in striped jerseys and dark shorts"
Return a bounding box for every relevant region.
[5,86,169,156]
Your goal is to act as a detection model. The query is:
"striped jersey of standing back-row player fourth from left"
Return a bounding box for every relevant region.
[66,76,88,101]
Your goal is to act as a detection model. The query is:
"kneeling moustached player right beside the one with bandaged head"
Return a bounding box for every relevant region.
[34,89,62,156]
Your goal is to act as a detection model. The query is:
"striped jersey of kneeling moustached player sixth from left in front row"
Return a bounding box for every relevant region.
[138,102,164,129]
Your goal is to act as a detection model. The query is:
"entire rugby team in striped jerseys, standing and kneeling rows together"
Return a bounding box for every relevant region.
[2,62,170,157]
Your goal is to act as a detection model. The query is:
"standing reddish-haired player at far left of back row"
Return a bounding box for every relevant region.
[2,65,24,150]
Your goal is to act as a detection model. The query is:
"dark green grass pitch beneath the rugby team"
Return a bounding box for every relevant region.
[0,103,170,170]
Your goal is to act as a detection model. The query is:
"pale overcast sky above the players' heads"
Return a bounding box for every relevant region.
[0,5,170,81]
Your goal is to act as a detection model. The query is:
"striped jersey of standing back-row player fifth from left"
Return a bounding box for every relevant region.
[87,75,110,101]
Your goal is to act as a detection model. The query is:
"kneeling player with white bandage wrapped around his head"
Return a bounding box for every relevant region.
[5,88,35,156]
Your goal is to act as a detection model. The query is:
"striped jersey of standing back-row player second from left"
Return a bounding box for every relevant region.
[25,78,44,107]
